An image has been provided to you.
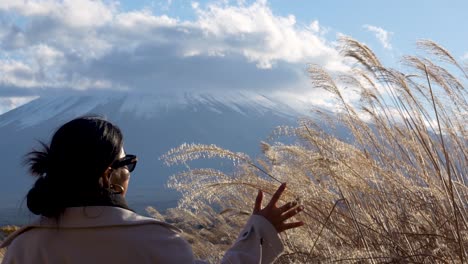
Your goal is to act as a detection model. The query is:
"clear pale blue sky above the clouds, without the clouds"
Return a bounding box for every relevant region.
[120,0,468,57]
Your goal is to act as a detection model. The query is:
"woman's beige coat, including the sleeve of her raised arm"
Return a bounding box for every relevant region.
[0,206,283,264]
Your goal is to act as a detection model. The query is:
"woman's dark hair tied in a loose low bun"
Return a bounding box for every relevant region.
[25,116,123,218]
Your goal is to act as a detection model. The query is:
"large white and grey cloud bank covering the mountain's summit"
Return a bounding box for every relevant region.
[0,0,347,96]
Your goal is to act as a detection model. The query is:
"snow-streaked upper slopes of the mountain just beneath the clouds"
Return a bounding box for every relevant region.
[0,91,305,129]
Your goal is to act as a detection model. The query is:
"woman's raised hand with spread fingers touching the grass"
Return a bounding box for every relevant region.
[253,183,304,233]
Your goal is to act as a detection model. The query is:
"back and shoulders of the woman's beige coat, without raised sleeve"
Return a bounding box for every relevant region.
[2,206,193,263]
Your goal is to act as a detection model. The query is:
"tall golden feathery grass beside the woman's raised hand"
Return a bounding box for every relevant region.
[163,37,468,263]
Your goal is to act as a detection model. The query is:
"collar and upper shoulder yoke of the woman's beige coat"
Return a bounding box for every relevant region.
[0,206,182,248]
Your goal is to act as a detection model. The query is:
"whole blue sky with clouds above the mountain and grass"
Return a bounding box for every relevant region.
[0,0,468,113]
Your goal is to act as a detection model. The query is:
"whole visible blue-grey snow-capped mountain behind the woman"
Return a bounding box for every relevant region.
[0,92,307,225]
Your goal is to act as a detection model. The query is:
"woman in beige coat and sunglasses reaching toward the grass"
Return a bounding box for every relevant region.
[0,117,302,263]
